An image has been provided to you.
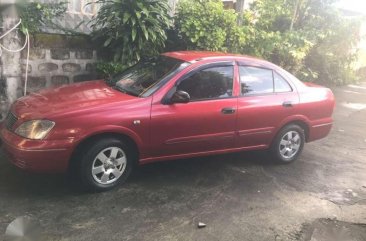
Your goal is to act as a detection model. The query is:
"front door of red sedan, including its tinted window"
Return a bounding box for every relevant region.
[151,61,237,157]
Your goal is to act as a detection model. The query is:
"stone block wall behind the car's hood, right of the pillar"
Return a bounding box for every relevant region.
[21,34,97,92]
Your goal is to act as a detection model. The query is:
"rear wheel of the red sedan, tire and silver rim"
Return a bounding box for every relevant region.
[270,124,305,164]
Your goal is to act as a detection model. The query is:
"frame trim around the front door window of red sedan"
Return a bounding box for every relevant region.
[161,60,237,105]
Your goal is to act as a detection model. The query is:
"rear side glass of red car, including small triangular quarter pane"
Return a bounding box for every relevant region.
[239,66,292,95]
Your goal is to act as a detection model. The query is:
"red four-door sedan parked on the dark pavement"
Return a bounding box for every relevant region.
[0,52,334,190]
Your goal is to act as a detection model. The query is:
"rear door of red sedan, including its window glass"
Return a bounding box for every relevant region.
[236,65,299,148]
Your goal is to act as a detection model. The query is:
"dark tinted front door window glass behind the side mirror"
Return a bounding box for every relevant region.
[177,66,234,101]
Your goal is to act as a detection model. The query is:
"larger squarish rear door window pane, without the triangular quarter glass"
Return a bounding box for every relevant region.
[239,66,274,95]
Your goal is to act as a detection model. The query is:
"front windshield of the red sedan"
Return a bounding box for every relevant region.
[107,56,189,97]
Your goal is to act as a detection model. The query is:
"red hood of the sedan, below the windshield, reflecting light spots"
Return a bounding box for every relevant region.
[12,80,138,119]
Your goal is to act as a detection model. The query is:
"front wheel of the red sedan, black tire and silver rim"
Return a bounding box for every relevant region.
[79,138,133,192]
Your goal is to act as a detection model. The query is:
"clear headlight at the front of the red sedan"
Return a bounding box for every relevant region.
[15,120,55,140]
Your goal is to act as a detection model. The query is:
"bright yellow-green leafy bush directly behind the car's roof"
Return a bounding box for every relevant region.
[175,0,244,52]
